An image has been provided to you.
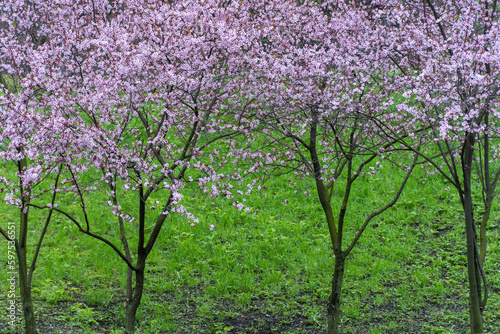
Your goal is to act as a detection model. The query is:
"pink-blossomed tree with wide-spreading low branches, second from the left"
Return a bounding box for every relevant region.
[2,0,262,333]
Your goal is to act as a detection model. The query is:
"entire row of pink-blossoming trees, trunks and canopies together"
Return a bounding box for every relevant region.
[0,0,500,334]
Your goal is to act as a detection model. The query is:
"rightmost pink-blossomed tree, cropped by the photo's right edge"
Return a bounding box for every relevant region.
[368,0,500,333]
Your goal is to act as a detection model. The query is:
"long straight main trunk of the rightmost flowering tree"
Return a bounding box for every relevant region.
[462,134,483,334]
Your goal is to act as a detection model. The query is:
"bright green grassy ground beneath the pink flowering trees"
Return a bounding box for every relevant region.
[0,163,500,334]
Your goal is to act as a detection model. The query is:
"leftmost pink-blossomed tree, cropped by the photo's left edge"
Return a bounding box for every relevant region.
[0,2,70,334]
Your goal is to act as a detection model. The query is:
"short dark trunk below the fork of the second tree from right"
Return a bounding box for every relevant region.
[327,251,345,334]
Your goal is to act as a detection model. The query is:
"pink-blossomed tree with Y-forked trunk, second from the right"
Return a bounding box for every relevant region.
[221,1,423,333]
